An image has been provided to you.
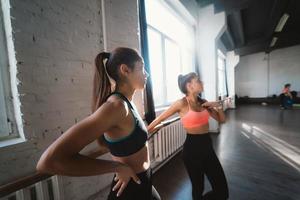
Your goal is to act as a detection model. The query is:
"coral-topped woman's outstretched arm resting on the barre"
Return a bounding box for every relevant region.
[148,100,182,133]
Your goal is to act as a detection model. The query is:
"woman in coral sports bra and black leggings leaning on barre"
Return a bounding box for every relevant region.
[148,72,228,200]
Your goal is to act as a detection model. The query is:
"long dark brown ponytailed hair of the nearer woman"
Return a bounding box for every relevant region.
[92,47,142,112]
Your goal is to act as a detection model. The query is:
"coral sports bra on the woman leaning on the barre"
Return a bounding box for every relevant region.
[181,98,210,129]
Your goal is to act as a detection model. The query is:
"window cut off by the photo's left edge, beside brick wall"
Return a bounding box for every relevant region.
[0,1,22,143]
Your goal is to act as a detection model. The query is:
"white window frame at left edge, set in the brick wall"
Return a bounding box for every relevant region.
[0,1,26,145]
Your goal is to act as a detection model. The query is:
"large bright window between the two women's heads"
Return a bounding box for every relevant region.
[146,0,195,108]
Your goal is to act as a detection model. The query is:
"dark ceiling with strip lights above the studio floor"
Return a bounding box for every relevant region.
[197,0,300,56]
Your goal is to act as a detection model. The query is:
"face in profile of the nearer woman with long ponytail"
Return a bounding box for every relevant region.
[128,61,149,89]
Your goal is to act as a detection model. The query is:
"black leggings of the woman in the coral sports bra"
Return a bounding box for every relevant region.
[183,134,228,200]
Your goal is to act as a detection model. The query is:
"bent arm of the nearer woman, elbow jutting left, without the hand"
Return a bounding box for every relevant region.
[37,102,135,178]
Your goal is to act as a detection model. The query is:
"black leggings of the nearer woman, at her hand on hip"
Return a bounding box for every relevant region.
[107,169,160,200]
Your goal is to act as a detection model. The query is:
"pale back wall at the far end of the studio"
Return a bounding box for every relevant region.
[235,45,300,97]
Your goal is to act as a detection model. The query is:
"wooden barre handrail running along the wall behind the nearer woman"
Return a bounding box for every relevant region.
[0,117,180,198]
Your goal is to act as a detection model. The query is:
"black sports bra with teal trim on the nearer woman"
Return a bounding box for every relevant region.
[102,92,148,157]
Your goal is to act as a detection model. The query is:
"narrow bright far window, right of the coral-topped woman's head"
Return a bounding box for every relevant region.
[218,50,227,99]
